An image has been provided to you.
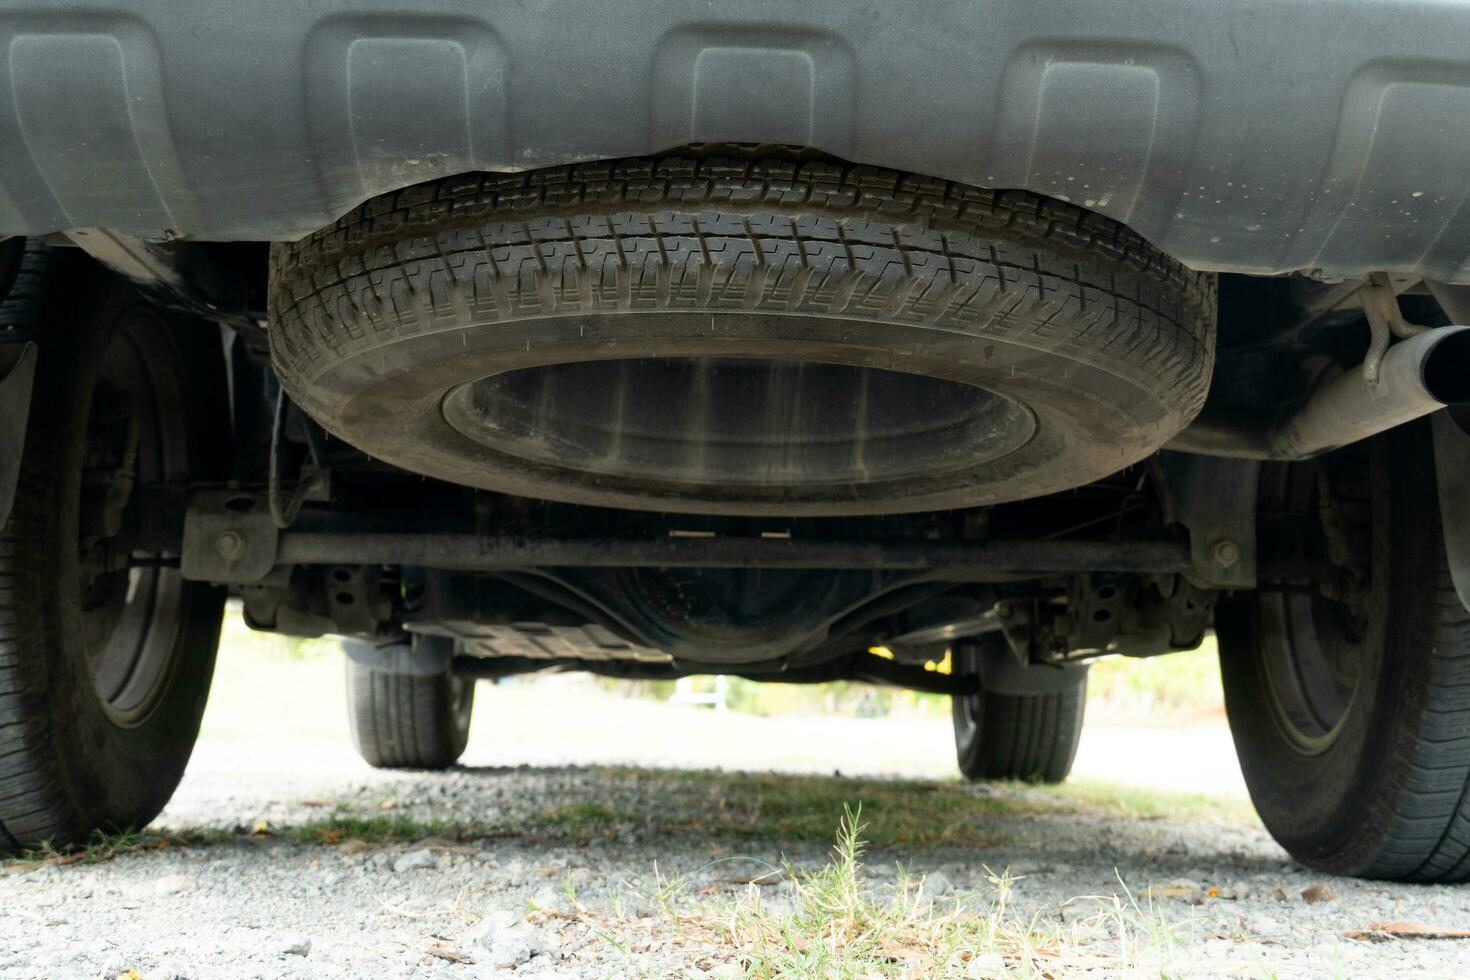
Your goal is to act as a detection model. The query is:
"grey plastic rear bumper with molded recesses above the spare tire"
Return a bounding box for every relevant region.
[0,0,1470,282]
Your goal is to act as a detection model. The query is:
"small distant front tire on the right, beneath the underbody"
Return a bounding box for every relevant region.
[951,646,1088,783]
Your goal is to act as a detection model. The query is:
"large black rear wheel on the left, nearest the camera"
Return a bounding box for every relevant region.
[0,242,229,849]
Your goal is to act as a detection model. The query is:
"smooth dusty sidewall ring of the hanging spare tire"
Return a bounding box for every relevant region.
[301,310,1158,514]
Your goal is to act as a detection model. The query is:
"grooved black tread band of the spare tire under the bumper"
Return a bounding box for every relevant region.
[270,157,1216,419]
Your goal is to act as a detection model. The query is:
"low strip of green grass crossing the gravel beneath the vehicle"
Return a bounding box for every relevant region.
[8,767,1252,864]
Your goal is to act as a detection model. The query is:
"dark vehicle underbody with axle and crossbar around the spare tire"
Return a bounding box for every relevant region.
[11,155,1470,692]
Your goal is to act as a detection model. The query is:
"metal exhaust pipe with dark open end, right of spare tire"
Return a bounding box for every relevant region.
[1164,326,1470,460]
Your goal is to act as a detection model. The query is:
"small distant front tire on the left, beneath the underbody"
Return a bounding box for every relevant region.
[344,658,475,768]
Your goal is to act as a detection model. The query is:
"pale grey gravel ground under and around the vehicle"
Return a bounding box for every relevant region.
[0,664,1470,980]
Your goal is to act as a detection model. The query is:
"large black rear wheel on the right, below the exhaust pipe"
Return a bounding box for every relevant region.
[1216,422,1470,882]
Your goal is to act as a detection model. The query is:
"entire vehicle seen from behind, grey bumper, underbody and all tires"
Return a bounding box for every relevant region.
[0,0,1470,882]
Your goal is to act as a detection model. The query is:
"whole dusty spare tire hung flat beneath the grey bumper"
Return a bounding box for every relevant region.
[270,157,1216,514]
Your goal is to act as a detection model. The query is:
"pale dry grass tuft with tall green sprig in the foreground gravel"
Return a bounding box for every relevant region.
[613,808,1228,980]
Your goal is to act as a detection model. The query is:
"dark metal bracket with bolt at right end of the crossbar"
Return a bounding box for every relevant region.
[1158,453,1261,589]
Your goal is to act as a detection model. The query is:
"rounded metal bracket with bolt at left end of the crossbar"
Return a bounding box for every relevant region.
[179,489,279,585]
